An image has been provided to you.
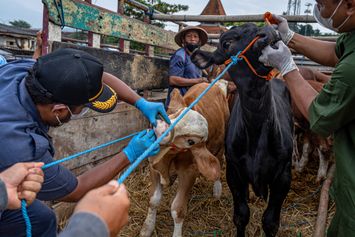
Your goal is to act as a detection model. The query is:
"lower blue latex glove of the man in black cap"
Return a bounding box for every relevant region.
[123,130,160,163]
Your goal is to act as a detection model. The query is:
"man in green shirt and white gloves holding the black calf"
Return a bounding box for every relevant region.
[259,0,355,237]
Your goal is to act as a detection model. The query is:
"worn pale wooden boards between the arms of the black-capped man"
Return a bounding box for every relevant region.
[50,103,149,173]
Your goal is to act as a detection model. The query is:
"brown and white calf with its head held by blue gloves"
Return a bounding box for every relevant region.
[140,83,229,237]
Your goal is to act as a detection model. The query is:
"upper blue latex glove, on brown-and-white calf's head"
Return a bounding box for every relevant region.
[134,98,171,127]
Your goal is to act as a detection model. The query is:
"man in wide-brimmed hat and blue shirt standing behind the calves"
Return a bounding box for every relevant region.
[166,26,208,107]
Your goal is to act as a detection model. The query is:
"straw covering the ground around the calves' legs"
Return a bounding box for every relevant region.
[119,156,335,237]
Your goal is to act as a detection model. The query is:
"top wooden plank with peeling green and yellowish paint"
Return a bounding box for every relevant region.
[42,0,178,49]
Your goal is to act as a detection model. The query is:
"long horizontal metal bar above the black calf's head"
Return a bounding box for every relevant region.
[152,13,316,23]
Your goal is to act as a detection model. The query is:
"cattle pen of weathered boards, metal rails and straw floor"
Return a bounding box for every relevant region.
[37,0,335,237]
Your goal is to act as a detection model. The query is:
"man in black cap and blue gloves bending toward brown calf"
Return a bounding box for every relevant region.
[0,49,170,237]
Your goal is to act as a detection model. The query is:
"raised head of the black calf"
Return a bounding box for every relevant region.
[191,23,281,84]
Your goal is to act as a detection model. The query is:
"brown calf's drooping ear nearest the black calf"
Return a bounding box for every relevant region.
[190,143,221,181]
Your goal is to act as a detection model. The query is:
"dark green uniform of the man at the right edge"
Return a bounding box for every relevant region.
[309,32,355,237]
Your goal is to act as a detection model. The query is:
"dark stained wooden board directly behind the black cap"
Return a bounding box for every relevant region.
[52,42,169,90]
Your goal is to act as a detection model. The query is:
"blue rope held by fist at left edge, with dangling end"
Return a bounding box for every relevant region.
[21,132,139,237]
